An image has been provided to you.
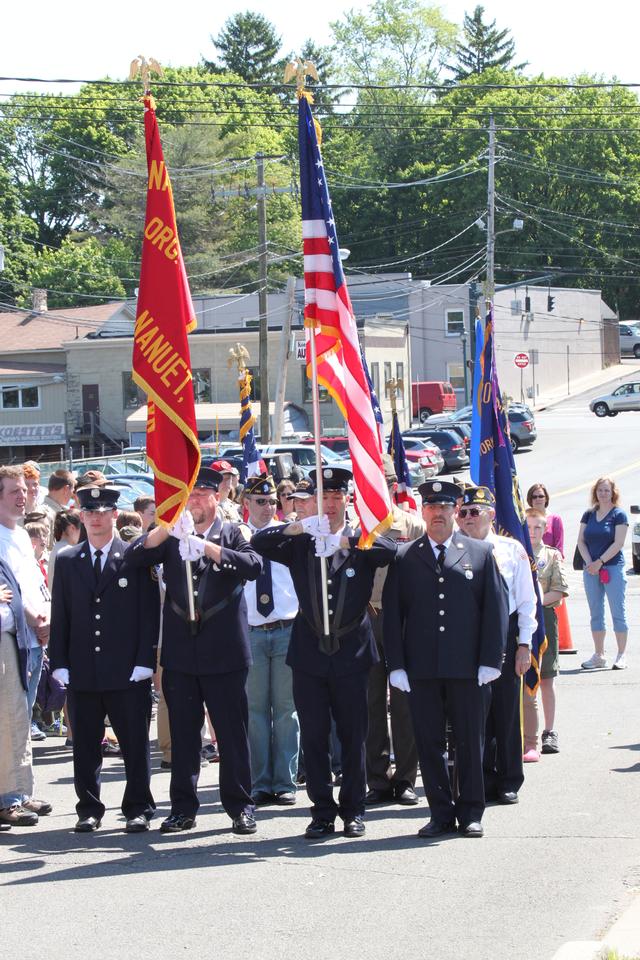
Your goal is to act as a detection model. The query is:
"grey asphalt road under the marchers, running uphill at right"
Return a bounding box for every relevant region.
[0,370,640,960]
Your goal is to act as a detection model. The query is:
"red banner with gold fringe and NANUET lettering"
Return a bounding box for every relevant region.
[133,95,200,526]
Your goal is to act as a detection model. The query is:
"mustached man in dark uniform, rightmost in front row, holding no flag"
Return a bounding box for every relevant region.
[382,480,508,838]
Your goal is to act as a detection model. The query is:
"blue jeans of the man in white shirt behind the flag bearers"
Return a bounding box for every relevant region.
[247,625,300,795]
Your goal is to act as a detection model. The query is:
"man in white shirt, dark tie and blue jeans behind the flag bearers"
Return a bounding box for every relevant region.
[242,474,300,806]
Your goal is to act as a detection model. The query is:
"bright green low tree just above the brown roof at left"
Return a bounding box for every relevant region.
[18,237,125,307]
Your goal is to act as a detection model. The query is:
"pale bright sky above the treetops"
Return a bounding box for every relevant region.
[0,0,640,94]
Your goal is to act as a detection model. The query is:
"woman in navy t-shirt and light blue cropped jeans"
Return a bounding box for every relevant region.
[578,477,629,670]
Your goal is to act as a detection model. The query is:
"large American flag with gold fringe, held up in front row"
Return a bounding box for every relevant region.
[298,96,392,547]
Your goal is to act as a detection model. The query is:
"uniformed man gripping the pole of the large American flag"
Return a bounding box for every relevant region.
[251,467,396,840]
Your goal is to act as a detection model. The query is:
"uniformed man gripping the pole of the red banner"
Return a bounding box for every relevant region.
[132,467,261,834]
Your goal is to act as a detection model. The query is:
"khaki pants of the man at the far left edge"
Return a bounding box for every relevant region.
[0,632,33,808]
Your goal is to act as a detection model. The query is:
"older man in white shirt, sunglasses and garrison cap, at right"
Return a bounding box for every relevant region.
[458,487,537,804]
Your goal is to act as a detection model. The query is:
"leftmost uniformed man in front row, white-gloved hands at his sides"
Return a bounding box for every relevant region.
[49,486,160,833]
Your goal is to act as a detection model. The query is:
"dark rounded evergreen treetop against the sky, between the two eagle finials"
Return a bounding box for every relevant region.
[205,10,284,83]
